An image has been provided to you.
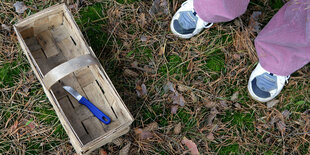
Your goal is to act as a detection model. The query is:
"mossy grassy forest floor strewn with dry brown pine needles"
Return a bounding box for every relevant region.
[0,0,310,154]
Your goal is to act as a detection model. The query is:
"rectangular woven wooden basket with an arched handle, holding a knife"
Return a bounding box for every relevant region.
[14,4,133,154]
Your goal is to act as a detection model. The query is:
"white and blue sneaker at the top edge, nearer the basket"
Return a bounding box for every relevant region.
[170,0,213,39]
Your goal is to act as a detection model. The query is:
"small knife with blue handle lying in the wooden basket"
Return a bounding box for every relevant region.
[63,86,111,124]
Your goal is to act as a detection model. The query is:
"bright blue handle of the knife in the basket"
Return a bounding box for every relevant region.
[79,97,111,124]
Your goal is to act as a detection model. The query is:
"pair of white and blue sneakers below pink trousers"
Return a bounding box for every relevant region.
[170,0,290,102]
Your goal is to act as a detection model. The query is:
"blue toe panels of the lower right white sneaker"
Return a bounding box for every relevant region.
[252,73,278,98]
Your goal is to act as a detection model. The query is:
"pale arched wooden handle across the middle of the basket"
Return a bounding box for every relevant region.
[43,54,99,90]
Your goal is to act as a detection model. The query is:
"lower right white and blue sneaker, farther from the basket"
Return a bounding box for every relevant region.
[248,63,290,102]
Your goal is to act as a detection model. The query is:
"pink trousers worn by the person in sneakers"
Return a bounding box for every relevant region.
[194,0,310,76]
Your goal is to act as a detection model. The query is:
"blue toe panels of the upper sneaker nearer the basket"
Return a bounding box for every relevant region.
[173,11,198,34]
